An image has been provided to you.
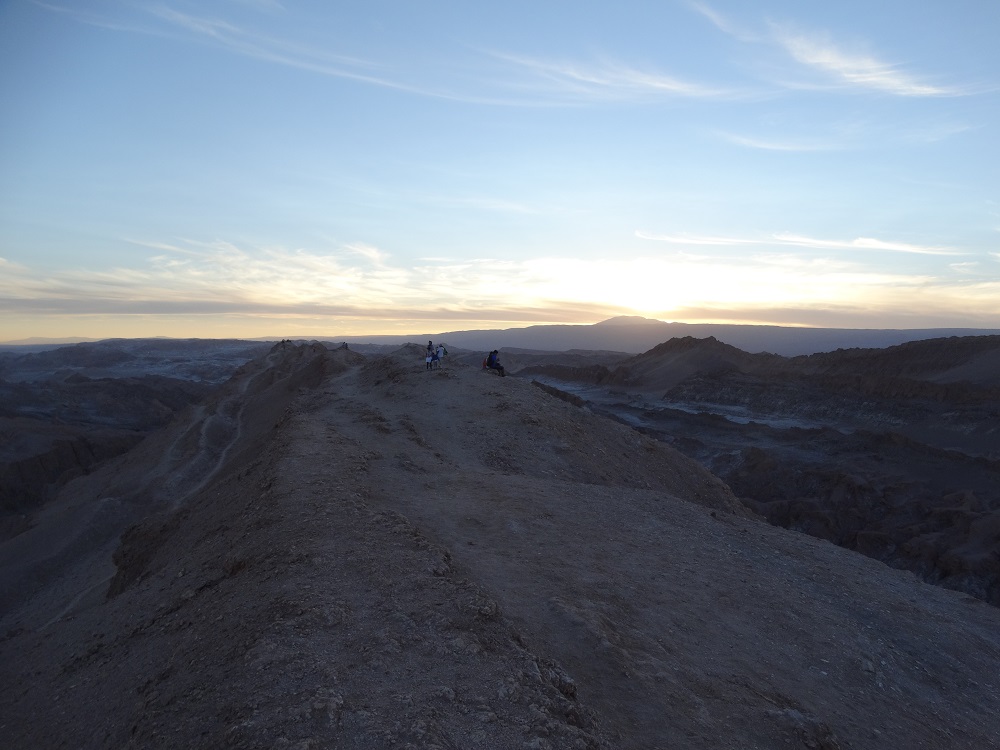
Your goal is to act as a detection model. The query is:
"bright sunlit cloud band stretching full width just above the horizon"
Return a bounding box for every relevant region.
[0,235,1000,338]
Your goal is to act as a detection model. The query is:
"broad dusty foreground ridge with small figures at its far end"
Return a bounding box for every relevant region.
[0,343,1000,748]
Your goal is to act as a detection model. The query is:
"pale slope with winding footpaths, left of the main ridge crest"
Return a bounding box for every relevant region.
[0,346,315,628]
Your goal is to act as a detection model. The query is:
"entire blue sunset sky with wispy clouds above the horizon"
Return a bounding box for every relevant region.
[0,0,1000,341]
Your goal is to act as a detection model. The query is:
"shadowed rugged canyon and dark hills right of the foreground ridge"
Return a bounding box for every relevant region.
[521,336,1000,605]
